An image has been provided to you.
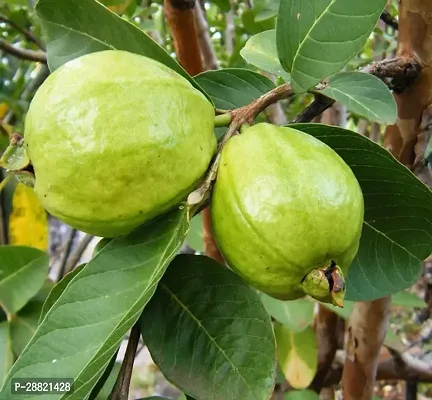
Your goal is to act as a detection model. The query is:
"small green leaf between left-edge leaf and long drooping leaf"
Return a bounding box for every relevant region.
[10,301,43,357]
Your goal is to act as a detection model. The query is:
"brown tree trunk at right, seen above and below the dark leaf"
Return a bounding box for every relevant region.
[342,0,432,400]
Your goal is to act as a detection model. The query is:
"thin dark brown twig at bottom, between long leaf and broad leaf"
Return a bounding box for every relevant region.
[108,322,140,400]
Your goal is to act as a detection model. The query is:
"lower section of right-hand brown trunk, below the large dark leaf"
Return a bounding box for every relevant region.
[342,297,391,400]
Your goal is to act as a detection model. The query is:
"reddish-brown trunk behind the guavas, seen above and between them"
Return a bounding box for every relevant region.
[164,0,223,262]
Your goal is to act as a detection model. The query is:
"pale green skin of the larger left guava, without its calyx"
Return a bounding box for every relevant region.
[25,50,216,237]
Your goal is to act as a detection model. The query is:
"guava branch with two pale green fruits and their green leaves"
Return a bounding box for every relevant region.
[0,0,432,400]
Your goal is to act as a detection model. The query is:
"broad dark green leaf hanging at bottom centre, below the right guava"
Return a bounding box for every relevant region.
[140,255,276,400]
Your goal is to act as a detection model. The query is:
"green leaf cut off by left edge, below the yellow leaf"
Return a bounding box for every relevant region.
[0,246,49,315]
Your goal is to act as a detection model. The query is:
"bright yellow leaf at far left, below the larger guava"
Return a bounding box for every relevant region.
[9,183,48,251]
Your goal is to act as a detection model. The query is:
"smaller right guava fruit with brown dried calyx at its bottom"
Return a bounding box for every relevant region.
[211,123,364,305]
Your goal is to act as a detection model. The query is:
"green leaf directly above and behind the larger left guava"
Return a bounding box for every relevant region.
[36,0,208,101]
